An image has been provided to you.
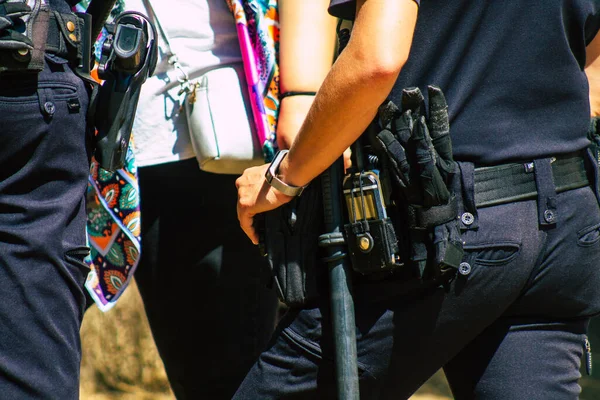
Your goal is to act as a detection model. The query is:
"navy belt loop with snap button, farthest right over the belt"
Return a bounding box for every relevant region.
[533,158,557,226]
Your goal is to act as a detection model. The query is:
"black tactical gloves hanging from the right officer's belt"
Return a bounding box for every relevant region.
[371,86,463,279]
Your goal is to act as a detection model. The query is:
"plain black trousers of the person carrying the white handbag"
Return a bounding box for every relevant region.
[135,159,278,400]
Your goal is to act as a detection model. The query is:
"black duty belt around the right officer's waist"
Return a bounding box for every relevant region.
[475,153,589,208]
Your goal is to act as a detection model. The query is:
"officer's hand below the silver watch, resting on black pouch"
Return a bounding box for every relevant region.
[235,164,293,244]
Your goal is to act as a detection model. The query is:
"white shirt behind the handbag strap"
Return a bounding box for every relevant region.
[126,0,242,167]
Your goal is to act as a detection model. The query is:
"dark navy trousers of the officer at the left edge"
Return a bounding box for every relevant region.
[0,59,90,400]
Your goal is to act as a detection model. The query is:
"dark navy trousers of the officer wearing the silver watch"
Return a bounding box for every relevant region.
[234,155,600,400]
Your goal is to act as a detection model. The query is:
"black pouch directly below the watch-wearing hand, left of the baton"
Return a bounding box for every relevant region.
[259,178,326,308]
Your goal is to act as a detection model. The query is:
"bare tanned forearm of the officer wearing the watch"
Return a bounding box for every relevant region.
[279,0,418,186]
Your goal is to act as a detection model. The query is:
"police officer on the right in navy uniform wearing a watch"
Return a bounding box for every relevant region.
[234,0,600,399]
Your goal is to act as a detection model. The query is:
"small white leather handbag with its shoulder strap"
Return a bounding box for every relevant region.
[144,0,265,174]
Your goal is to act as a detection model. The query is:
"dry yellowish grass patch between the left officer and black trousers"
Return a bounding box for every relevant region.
[80,282,174,400]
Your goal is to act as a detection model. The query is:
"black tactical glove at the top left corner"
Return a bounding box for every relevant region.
[0,0,33,51]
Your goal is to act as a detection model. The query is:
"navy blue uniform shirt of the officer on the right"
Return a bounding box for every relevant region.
[329,0,600,165]
